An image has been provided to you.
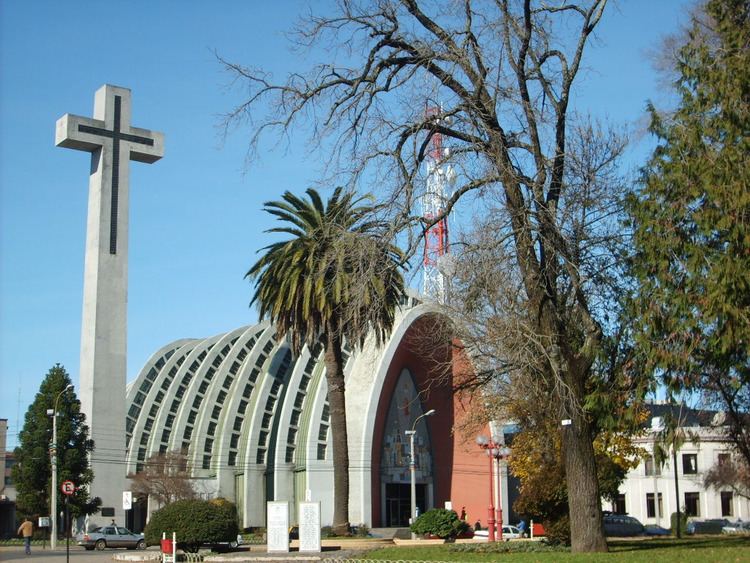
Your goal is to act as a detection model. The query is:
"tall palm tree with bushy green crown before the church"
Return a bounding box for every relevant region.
[246,187,404,534]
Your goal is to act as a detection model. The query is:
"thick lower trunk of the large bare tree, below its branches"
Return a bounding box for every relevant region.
[562,409,607,553]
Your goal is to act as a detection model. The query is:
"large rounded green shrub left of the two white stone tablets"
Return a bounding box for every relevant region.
[144,499,238,552]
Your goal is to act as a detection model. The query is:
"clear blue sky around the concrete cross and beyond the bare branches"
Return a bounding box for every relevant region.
[0,0,691,448]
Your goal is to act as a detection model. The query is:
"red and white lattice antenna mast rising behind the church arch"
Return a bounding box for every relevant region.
[422,107,455,303]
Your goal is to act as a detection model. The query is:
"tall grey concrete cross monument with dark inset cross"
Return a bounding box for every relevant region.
[55,84,164,525]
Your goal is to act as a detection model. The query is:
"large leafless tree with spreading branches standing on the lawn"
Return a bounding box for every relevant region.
[223,0,624,551]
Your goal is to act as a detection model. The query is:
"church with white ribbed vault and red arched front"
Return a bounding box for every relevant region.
[125,298,500,529]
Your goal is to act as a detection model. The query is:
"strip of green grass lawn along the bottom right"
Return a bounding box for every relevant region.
[361,536,750,563]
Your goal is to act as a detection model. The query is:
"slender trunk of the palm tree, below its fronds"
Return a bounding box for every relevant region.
[325,327,349,535]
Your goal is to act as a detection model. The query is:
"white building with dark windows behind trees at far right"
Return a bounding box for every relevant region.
[604,404,750,528]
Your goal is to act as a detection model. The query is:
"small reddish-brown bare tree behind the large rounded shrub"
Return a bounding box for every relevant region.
[128,452,196,506]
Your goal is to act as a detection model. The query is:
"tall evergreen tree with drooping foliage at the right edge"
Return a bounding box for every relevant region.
[631,0,750,465]
